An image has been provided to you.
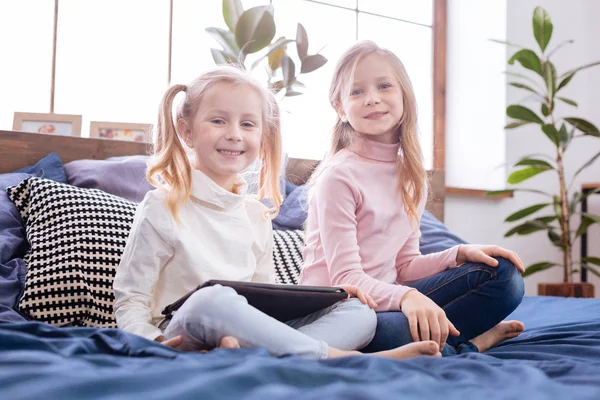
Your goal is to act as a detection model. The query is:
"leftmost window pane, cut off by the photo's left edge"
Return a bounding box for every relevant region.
[0,0,54,130]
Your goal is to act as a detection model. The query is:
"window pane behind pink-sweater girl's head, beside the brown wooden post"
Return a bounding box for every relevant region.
[358,14,433,169]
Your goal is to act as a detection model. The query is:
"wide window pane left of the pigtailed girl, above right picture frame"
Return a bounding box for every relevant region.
[55,0,169,136]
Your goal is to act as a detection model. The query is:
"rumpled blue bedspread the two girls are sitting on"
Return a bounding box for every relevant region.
[0,297,600,400]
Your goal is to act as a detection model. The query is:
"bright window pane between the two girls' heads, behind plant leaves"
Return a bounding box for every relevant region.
[273,0,356,159]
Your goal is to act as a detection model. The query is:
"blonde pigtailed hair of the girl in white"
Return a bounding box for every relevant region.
[146,66,282,222]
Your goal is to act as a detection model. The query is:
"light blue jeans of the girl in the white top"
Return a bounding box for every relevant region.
[165,285,377,359]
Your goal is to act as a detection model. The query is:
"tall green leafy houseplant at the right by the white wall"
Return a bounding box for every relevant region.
[488,7,600,290]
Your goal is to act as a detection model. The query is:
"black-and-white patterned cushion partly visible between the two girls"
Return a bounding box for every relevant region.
[273,230,304,285]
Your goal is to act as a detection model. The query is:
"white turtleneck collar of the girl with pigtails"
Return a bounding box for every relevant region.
[191,168,248,208]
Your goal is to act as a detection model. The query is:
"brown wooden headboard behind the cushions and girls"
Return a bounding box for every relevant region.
[0,131,445,221]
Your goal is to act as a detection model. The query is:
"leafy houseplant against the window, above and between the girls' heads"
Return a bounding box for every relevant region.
[206,0,327,96]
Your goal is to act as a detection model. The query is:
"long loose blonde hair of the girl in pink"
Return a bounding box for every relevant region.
[315,40,427,229]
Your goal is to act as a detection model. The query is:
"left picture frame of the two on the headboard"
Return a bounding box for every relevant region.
[13,111,81,136]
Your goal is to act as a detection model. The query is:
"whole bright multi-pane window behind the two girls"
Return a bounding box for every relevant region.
[0,0,434,168]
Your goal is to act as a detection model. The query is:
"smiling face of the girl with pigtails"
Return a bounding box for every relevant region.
[179,82,263,190]
